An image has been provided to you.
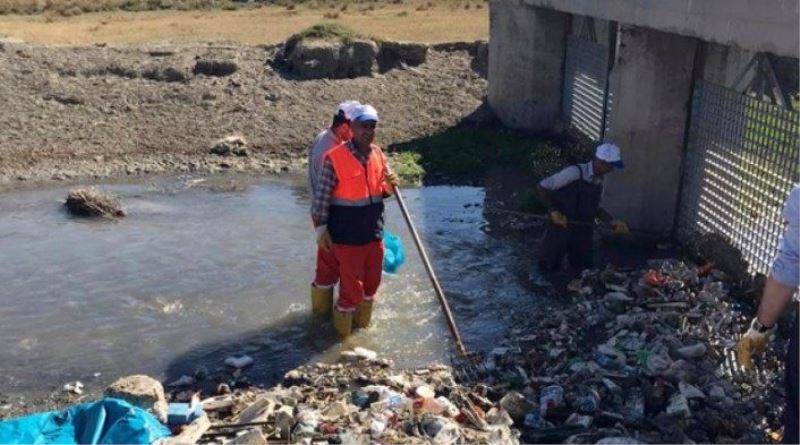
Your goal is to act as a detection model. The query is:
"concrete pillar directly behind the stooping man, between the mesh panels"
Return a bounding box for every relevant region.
[603,26,697,233]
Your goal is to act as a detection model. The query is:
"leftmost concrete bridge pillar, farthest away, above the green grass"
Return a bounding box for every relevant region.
[488,0,570,131]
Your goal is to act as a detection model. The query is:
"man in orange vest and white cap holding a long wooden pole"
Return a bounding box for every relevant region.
[312,105,398,338]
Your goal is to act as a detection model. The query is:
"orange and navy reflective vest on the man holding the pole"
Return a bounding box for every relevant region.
[325,143,386,246]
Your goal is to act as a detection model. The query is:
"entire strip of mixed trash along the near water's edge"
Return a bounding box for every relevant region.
[0,259,783,444]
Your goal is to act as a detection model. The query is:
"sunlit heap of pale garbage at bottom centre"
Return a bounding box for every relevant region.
[159,348,518,444]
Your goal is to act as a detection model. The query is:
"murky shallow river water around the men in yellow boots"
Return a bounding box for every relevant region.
[0,173,533,393]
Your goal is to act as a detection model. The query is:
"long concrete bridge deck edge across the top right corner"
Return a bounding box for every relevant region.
[523,0,800,57]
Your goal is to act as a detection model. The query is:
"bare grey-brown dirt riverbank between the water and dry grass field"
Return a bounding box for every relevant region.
[0,41,487,188]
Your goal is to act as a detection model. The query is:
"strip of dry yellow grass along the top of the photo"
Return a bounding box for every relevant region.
[0,0,489,45]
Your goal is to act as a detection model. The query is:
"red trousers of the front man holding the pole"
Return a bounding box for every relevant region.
[331,241,383,312]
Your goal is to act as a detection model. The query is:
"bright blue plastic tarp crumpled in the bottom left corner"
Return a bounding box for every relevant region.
[0,399,170,444]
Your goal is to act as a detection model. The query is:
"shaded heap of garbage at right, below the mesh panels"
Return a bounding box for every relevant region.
[457,260,782,443]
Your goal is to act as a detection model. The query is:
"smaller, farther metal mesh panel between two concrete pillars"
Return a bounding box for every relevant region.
[562,35,608,141]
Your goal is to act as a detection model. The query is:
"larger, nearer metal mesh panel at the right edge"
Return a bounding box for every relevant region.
[678,82,800,273]
